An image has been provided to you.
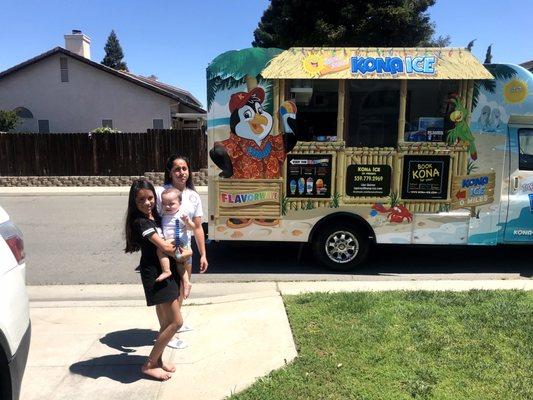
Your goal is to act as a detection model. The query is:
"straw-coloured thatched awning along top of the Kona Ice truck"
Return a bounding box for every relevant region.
[261,47,494,79]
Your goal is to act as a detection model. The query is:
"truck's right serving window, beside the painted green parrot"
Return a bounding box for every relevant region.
[404,80,459,142]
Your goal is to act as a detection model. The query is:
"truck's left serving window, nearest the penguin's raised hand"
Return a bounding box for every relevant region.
[287,79,339,141]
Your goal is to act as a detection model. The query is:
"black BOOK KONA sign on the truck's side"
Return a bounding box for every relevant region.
[402,155,450,200]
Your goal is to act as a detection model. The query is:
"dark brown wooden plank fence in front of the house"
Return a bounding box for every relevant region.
[0,129,207,176]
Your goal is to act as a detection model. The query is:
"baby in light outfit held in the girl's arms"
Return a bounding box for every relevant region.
[156,188,194,298]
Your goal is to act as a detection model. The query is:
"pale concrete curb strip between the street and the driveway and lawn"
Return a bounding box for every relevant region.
[28,279,533,308]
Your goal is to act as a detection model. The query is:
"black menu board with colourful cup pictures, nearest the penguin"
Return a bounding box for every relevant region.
[286,154,332,198]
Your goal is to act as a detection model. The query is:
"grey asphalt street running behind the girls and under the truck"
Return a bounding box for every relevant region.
[0,194,533,285]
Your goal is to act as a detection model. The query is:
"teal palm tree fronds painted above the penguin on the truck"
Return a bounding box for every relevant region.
[207,47,283,113]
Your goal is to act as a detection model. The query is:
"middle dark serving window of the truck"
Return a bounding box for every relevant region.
[345,79,400,147]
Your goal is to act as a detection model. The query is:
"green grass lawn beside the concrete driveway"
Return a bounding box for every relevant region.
[231,291,533,400]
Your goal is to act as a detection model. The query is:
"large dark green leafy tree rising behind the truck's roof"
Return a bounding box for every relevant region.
[252,0,450,49]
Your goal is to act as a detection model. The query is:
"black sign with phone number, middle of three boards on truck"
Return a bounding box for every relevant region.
[346,164,391,197]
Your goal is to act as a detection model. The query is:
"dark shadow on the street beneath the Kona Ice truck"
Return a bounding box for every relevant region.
[193,238,533,277]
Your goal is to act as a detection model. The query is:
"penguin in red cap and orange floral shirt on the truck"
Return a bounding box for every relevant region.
[209,87,297,179]
